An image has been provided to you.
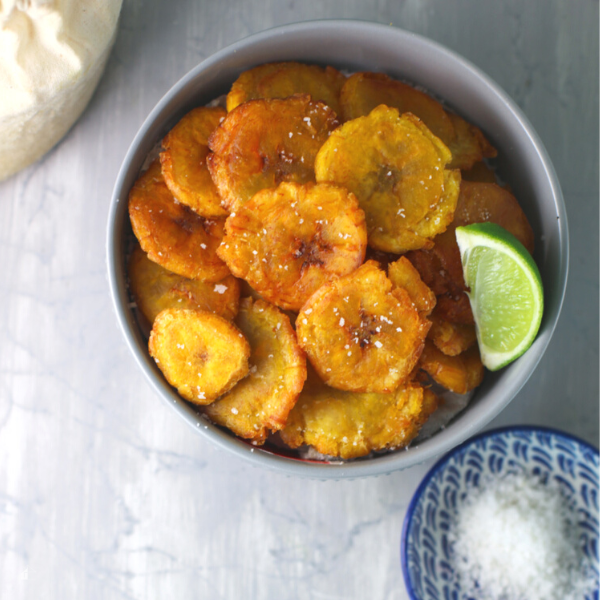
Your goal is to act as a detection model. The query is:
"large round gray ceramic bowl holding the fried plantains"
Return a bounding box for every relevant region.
[107,21,568,479]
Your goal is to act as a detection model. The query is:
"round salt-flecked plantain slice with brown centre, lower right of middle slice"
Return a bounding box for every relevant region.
[296,261,431,393]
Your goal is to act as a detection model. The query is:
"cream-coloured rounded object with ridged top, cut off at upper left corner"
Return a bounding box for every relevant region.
[0,0,122,180]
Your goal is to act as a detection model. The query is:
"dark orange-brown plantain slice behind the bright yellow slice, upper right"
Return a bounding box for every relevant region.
[340,73,497,169]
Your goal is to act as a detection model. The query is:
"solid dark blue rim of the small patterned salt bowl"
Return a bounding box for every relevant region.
[400,425,600,600]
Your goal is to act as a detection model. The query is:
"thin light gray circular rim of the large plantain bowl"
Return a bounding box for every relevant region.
[106,19,569,479]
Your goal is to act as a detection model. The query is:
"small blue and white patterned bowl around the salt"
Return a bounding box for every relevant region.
[401,426,599,600]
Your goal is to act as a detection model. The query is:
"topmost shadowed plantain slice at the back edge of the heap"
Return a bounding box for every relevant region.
[227,62,346,115]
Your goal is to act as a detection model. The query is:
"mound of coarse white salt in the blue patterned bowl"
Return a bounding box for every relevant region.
[449,473,594,600]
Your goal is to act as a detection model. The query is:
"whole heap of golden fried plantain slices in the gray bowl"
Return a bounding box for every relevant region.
[128,62,533,459]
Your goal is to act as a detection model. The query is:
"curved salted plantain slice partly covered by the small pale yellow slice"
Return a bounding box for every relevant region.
[205,298,306,444]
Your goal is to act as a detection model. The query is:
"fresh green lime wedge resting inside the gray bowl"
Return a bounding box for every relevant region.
[456,223,544,371]
